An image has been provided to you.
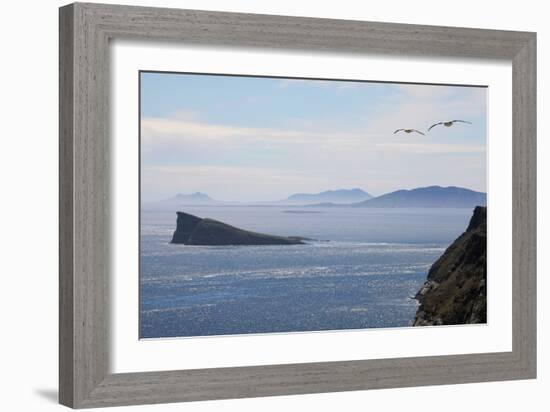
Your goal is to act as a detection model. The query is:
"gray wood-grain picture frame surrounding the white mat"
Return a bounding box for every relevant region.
[59,3,536,408]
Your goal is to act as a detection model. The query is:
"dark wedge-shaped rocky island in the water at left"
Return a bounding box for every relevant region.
[171,212,305,246]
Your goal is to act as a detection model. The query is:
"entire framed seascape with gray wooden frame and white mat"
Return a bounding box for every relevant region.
[60,3,536,408]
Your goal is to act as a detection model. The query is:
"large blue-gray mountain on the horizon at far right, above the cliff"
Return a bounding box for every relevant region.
[351,186,487,208]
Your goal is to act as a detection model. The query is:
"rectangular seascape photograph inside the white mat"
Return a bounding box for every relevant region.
[139,72,487,339]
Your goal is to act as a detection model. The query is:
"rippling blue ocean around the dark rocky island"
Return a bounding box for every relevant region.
[140,206,472,338]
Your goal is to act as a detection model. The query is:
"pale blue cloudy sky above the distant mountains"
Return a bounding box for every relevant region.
[140,72,487,201]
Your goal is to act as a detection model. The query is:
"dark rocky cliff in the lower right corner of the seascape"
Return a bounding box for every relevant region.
[413,206,487,326]
